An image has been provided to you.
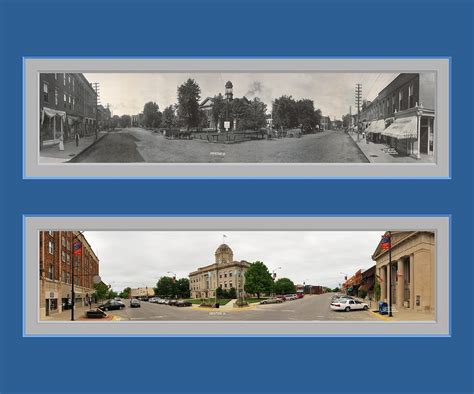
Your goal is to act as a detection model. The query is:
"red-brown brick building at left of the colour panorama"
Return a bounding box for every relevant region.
[39,231,99,317]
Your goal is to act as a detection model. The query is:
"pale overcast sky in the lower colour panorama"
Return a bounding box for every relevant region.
[84,230,384,290]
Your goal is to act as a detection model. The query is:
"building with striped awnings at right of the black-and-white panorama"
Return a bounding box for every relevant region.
[360,72,436,159]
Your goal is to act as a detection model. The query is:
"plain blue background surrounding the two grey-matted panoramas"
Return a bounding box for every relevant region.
[0,0,473,392]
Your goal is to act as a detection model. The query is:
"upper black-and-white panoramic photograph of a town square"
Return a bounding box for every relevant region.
[38,71,438,164]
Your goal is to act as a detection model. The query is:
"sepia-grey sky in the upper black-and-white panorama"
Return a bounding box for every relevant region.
[84,73,398,119]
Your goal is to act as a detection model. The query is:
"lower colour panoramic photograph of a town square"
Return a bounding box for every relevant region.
[38,229,436,322]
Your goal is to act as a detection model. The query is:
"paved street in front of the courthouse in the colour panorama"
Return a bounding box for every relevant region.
[103,294,378,321]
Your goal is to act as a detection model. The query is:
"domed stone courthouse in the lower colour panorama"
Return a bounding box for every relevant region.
[189,244,250,299]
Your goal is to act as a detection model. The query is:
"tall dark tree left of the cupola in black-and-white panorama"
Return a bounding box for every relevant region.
[178,78,201,130]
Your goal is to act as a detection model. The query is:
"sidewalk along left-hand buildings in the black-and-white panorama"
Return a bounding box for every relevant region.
[39,131,108,164]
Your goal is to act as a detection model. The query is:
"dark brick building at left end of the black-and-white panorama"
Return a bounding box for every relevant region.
[39,73,97,147]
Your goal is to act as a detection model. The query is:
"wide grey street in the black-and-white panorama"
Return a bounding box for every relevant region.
[74,128,368,163]
